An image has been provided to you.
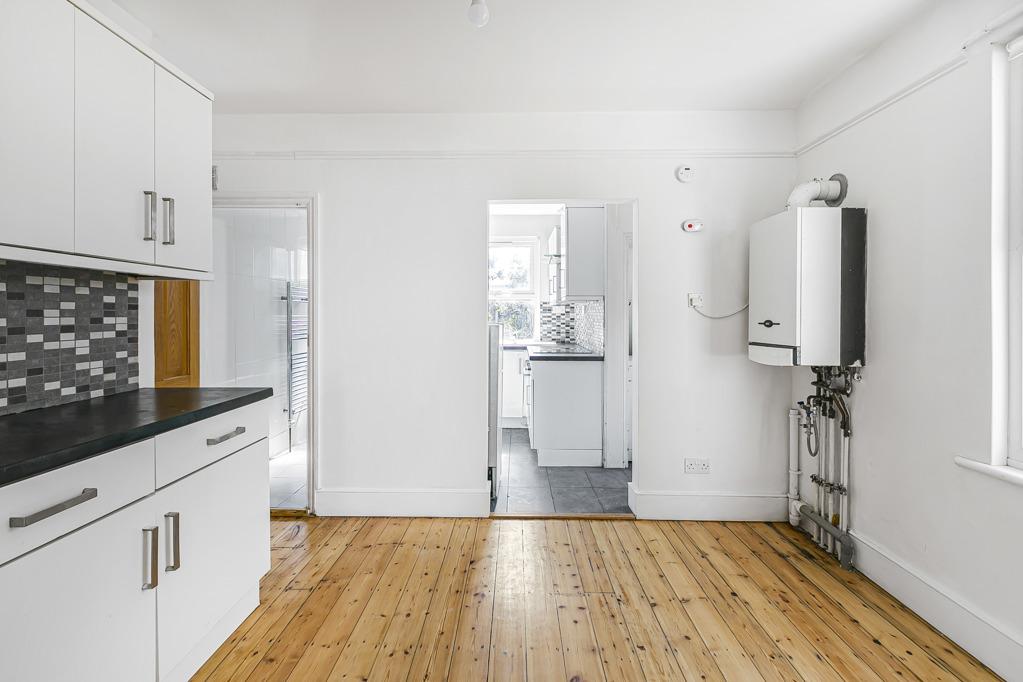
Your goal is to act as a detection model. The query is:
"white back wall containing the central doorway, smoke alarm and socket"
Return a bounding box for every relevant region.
[215,111,795,518]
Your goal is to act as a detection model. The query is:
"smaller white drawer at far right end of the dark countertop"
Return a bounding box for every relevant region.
[157,400,269,488]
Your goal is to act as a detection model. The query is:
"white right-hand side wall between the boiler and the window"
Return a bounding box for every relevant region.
[793,1,1023,679]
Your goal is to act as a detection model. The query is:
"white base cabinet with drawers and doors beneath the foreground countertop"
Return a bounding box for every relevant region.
[0,400,270,682]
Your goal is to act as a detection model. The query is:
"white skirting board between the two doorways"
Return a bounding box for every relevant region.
[315,485,490,517]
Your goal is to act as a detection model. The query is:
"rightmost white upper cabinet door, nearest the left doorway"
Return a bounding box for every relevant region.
[155,66,213,271]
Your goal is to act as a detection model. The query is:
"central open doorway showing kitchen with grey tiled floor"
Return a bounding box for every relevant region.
[487,200,634,515]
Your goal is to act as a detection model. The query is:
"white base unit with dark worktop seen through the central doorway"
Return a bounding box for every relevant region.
[529,347,604,466]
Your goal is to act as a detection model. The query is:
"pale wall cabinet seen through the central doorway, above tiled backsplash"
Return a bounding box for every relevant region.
[560,207,607,301]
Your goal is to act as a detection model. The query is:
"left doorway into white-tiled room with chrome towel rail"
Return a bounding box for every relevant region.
[207,197,315,514]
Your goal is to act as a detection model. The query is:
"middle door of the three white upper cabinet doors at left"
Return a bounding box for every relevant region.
[75,11,155,263]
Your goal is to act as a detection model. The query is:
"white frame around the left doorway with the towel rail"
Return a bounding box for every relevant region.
[213,191,319,515]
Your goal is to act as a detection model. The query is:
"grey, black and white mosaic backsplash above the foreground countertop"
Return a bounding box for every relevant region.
[0,261,139,415]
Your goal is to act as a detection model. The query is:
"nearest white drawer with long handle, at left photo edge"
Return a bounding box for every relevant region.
[0,439,153,563]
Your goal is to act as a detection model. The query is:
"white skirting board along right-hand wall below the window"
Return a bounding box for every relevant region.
[850,531,1023,680]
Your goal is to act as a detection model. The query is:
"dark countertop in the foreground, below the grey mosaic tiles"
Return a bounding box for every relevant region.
[0,389,273,486]
